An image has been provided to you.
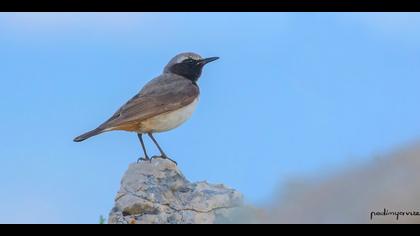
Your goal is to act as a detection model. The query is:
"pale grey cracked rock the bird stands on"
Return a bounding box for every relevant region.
[109,158,243,224]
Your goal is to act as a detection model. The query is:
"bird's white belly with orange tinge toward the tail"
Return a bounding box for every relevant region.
[140,98,198,133]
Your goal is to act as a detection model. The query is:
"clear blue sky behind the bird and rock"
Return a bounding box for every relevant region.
[0,13,420,223]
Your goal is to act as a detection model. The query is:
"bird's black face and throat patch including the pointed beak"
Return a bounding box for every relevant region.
[170,57,218,82]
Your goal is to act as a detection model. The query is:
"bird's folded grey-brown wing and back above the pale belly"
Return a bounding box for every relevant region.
[99,74,199,130]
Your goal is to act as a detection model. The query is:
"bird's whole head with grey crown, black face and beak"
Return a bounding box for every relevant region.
[164,52,219,82]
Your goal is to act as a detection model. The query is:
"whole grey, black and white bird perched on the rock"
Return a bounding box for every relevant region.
[74,53,219,163]
